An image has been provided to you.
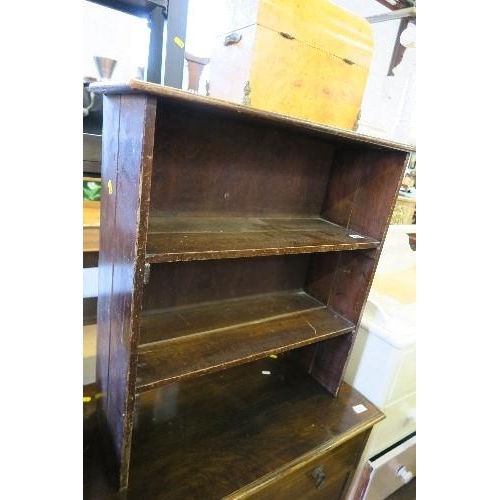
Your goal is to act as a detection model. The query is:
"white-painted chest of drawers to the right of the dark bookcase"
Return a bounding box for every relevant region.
[345,224,416,500]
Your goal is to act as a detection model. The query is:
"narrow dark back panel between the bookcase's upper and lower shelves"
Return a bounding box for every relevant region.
[143,255,309,311]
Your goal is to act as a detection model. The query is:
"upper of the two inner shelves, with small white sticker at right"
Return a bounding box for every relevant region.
[146,217,379,262]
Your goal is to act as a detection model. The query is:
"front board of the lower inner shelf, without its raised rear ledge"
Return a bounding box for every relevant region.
[136,294,355,393]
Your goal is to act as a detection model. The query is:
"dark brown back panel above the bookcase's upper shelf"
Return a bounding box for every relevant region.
[151,103,334,217]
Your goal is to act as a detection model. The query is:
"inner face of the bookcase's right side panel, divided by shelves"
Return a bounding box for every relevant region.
[300,147,409,395]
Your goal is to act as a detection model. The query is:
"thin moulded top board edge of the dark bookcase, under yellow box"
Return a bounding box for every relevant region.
[89,79,415,153]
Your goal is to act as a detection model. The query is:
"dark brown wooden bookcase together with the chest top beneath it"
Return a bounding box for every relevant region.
[91,80,413,492]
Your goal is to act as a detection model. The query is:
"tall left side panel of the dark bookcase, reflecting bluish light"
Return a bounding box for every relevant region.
[97,95,156,488]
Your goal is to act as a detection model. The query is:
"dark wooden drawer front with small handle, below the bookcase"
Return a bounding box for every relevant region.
[244,431,369,500]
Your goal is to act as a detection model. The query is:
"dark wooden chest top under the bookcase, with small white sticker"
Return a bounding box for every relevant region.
[124,355,383,499]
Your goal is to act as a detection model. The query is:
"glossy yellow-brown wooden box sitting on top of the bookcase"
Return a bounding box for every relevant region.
[210,0,373,130]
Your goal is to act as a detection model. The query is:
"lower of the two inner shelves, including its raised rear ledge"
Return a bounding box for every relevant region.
[137,290,355,392]
